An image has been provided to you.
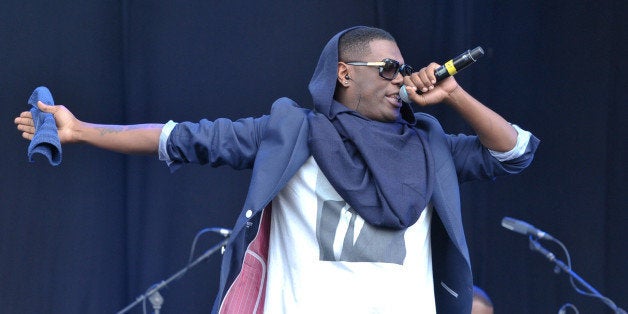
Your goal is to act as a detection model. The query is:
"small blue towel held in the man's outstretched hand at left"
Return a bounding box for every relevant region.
[28,86,61,166]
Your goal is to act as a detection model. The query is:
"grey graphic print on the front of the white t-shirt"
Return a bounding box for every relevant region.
[316,172,406,265]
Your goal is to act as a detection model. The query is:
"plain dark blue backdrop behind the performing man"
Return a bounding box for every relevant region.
[0,0,628,313]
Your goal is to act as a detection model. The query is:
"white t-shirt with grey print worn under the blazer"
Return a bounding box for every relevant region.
[264,157,436,314]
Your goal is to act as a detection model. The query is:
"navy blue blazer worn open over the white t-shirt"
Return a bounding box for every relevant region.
[167,98,539,313]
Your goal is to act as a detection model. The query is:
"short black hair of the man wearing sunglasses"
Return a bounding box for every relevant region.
[338,27,396,62]
